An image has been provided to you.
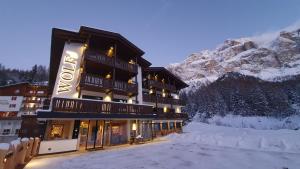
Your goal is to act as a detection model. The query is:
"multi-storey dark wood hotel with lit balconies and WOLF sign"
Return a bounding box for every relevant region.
[37,27,188,154]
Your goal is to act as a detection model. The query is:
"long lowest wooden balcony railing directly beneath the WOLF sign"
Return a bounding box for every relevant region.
[52,98,153,114]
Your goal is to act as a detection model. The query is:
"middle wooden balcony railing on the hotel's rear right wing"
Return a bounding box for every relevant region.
[143,94,185,105]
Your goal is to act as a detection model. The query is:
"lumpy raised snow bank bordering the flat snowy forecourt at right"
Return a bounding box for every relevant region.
[168,122,300,153]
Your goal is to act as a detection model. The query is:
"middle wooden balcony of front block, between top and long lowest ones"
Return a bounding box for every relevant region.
[80,74,138,95]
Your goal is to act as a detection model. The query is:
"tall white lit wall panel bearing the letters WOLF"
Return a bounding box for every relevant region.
[52,43,84,98]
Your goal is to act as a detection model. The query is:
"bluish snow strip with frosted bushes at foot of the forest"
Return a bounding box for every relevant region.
[206,115,300,130]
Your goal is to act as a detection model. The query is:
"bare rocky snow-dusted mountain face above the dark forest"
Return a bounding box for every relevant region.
[167,26,300,89]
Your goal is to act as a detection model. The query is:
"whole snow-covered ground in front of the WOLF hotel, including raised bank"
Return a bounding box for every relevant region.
[26,122,300,169]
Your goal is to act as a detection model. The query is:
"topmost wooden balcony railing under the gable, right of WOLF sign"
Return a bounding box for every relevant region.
[85,52,138,73]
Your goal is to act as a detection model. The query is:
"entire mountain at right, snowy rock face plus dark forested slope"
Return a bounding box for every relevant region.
[167,29,300,117]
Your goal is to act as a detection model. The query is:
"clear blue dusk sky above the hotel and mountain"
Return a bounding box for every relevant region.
[0,0,300,69]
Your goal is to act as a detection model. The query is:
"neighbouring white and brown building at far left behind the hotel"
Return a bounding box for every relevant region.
[0,83,48,142]
